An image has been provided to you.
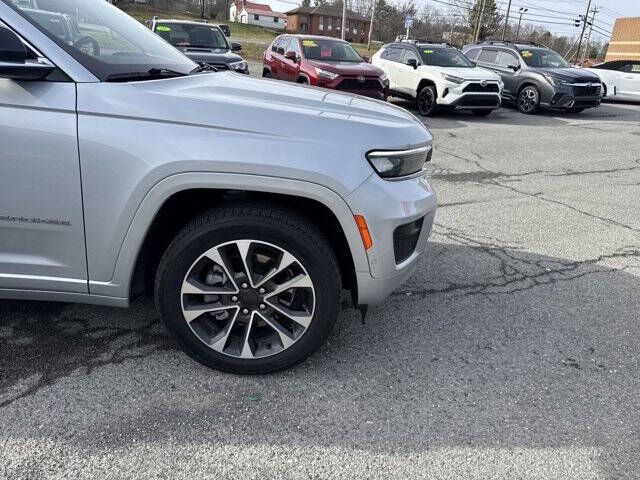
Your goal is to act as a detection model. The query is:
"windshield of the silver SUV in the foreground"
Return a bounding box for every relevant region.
[5,0,197,80]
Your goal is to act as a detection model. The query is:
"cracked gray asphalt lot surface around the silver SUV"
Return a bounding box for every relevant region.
[0,102,640,479]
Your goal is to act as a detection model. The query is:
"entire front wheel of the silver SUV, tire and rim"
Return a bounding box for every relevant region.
[155,204,341,374]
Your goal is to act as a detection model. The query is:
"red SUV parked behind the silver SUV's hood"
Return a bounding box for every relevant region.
[262,35,389,100]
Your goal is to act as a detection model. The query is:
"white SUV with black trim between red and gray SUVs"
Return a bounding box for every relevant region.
[371,41,504,116]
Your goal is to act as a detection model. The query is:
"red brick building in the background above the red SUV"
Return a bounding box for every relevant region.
[286,5,370,43]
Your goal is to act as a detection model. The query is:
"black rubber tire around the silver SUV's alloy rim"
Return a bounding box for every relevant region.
[155,203,341,374]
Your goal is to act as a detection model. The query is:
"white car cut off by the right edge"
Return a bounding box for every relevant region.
[585,60,640,101]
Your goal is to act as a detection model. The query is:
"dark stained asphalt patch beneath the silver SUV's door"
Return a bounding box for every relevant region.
[0,302,175,408]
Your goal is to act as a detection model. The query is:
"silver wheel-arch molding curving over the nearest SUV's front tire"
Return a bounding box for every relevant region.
[89,172,369,298]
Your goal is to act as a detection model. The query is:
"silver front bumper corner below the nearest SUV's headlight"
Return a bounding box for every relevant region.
[346,169,436,305]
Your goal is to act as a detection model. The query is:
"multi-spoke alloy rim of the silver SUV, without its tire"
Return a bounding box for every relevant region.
[180,240,316,359]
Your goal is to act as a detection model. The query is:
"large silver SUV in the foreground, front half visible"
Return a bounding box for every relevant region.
[0,0,436,373]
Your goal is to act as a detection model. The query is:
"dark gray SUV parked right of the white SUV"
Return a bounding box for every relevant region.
[462,41,602,113]
